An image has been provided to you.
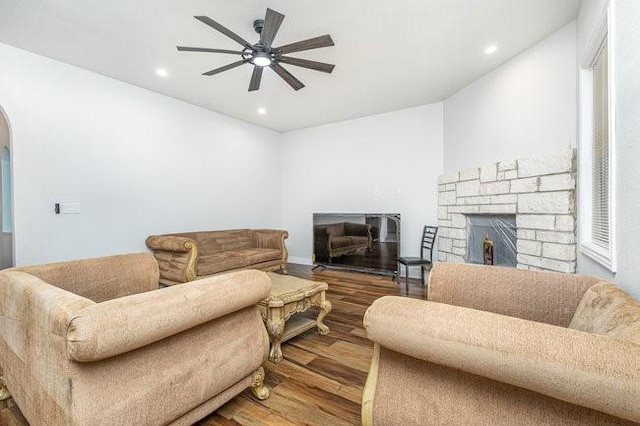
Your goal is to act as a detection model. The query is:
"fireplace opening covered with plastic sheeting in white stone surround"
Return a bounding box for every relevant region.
[467,215,517,267]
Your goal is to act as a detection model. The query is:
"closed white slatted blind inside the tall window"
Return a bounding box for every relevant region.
[591,40,610,250]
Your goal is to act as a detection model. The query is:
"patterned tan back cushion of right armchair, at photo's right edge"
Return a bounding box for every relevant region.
[569,282,640,344]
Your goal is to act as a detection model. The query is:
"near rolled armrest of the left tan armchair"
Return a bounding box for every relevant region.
[66,270,271,362]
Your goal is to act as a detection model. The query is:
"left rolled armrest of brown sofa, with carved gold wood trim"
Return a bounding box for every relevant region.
[146,235,198,282]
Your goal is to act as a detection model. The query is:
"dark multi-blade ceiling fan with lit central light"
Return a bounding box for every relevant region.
[176,9,335,92]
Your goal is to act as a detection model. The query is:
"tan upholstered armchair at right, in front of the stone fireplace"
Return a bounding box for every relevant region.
[362,263,640,425]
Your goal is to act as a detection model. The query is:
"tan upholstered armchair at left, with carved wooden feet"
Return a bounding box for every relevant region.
[0,254,271,426]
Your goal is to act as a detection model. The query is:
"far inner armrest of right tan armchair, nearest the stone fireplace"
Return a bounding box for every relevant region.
[428,262,600,327]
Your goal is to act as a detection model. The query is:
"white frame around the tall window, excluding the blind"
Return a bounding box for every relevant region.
[578,4,617,273]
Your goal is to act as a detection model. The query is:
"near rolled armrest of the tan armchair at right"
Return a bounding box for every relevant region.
[364,296,640,422]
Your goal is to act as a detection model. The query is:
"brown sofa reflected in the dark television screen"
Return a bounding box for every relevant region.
[313,222,373,262]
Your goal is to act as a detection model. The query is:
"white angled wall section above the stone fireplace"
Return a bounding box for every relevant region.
[444,22,577,173]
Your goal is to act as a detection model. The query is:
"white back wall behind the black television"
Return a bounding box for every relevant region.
[282,103,443,263]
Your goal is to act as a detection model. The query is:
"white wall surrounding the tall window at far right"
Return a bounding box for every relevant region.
[578,0,640,298]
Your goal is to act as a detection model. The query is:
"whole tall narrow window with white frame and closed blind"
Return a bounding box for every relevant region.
[579,6,615,272]
